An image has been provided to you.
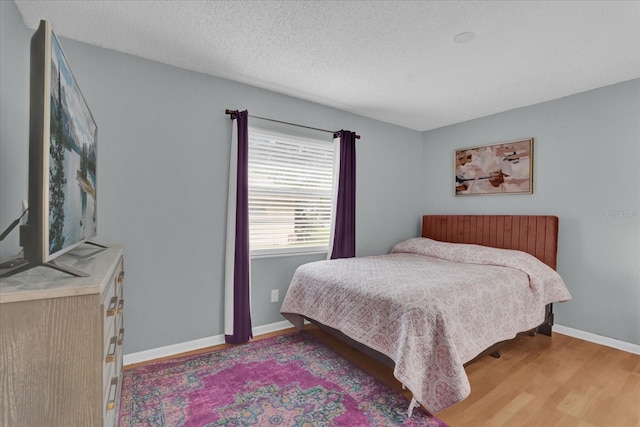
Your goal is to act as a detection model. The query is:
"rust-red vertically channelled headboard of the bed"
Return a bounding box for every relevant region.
[422,215,558,270]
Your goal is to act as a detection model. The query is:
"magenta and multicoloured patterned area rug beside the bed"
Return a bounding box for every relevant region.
[120,331,447,427]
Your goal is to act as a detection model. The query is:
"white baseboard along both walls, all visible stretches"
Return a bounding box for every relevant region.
[122,320,640,366]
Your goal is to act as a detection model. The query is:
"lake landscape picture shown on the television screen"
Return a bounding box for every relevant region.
[49,36,97,254]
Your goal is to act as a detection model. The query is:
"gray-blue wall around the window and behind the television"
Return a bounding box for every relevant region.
[0,1,425,354]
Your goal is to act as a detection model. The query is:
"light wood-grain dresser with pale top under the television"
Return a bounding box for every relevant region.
[0,245,124,427]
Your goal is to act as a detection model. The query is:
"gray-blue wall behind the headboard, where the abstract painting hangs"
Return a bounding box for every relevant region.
[423,80,640,344]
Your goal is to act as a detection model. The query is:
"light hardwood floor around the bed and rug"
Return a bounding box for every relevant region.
[125,325,640,427]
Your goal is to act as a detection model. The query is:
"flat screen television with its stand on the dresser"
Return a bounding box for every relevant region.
[7,20,98,275]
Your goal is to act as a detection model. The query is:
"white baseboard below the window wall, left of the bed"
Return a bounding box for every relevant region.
[122,320,293,366]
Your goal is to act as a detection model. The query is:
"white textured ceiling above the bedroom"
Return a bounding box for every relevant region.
[11,0,640,130]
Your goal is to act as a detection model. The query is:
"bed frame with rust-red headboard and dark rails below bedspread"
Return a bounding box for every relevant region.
[307,215,558,368]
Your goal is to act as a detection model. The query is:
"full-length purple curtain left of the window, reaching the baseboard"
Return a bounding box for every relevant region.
[225,110,253,344]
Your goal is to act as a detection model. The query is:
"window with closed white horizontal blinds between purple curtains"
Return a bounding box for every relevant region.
[249,128,334,256]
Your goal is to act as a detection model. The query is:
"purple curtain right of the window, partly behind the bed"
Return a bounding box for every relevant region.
[331,130,356,259]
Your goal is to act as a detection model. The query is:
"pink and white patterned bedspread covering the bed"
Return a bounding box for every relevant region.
[280,238,571,412]
